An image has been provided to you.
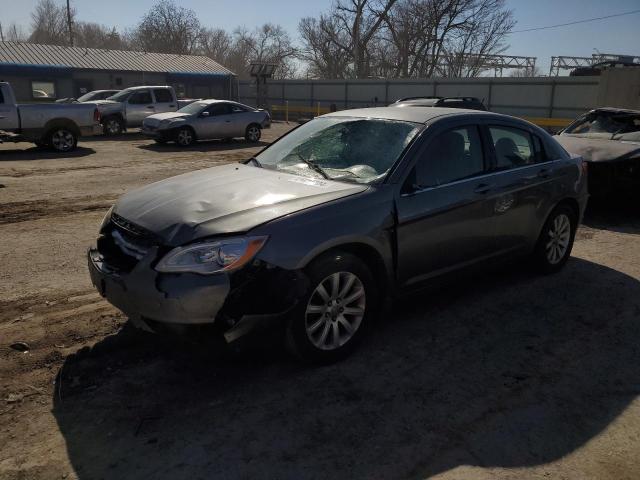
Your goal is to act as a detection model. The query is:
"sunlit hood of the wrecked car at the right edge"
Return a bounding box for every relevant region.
[554,134,640,162]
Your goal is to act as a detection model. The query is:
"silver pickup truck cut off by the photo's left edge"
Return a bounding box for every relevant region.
[0,82,101,152]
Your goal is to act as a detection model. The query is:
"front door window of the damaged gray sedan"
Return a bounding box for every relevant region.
[415,126,485,188]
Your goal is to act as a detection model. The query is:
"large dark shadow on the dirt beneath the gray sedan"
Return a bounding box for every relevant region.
[54,255,640,479]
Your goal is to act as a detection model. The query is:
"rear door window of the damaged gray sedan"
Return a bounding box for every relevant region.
[489,126,539,170]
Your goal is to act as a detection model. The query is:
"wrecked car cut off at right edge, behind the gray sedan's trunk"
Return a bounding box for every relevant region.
[556,108,640,197]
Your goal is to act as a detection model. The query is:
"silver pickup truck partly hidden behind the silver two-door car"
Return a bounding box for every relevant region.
[92,86,194,135]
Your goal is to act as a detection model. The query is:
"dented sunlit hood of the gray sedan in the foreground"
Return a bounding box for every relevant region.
[114,164,368,246]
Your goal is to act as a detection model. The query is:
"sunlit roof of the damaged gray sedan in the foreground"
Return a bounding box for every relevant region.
[323,107,504,123]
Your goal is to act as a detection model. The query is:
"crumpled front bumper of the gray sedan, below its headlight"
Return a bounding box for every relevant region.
[87,248,230,330]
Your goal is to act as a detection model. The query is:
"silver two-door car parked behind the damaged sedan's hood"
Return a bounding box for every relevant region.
[142,100,271,147]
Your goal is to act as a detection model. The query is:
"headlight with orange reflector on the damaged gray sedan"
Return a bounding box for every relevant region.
[156,237,267,275]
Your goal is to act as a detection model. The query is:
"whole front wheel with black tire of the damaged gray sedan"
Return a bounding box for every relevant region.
[286,252,379,364]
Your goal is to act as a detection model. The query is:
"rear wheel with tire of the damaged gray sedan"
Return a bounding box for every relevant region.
[533,204,578,273]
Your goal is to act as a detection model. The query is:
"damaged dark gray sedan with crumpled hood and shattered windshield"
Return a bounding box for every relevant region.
[88,107,587,362]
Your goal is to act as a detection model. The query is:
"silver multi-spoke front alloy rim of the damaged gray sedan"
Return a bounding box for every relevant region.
[305,272,366,350]
